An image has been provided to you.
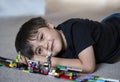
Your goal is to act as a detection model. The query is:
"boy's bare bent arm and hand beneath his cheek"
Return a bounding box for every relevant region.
[34,46,95,73]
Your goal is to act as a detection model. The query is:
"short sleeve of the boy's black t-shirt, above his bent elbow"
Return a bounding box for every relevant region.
[71,21,95,56]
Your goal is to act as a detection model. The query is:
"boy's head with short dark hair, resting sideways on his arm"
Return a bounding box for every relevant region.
[15,17,63,58]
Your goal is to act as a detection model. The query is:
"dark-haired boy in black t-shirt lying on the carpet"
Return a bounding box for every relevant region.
[15,13,120,73]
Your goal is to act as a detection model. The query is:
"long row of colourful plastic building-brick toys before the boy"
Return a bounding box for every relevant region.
[0,52,119,82]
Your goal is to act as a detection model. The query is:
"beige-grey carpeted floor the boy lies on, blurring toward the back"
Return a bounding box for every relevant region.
[0,0,120,82]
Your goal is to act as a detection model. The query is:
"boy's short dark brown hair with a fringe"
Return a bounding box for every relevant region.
[15,17,47,58]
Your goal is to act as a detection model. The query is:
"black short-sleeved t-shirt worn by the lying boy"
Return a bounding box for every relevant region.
[57,18,120,63]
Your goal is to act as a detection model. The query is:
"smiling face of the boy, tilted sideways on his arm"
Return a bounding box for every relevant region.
[29,27,63,56]
